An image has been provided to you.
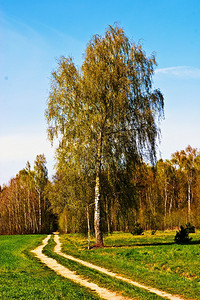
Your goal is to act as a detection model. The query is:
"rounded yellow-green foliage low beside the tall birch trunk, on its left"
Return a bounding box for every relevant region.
[47,168,94,233]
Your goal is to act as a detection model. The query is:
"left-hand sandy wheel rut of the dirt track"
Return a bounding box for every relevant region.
[32,235,131,300]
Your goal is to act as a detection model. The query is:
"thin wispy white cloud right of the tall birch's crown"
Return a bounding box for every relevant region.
[155,66,200,79]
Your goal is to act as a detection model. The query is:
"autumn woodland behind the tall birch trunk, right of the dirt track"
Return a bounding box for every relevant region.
[46,146,200,232]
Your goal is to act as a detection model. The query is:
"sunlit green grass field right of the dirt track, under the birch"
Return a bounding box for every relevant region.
[58,231,200,299]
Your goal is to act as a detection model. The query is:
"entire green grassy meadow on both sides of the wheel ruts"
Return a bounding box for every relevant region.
[0,231,200,299]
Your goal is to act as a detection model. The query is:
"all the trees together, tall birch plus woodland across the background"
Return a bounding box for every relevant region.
[0,24,200,241]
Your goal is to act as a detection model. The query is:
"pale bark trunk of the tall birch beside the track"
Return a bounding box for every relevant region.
[94,133,103,247]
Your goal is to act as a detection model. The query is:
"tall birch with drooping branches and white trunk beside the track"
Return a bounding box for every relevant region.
[46,25,163,246]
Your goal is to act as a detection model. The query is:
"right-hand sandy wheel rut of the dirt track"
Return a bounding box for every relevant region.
[54,234,183,300]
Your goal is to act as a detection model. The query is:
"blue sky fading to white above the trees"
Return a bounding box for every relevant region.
[0,0,200,185]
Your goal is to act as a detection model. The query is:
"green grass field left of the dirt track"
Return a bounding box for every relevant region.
[0,235,100,300]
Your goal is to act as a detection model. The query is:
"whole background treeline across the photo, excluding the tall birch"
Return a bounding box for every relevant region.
[0,146,200,234]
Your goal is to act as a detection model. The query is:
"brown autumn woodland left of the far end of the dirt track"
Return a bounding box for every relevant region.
[0,155,54,234]
